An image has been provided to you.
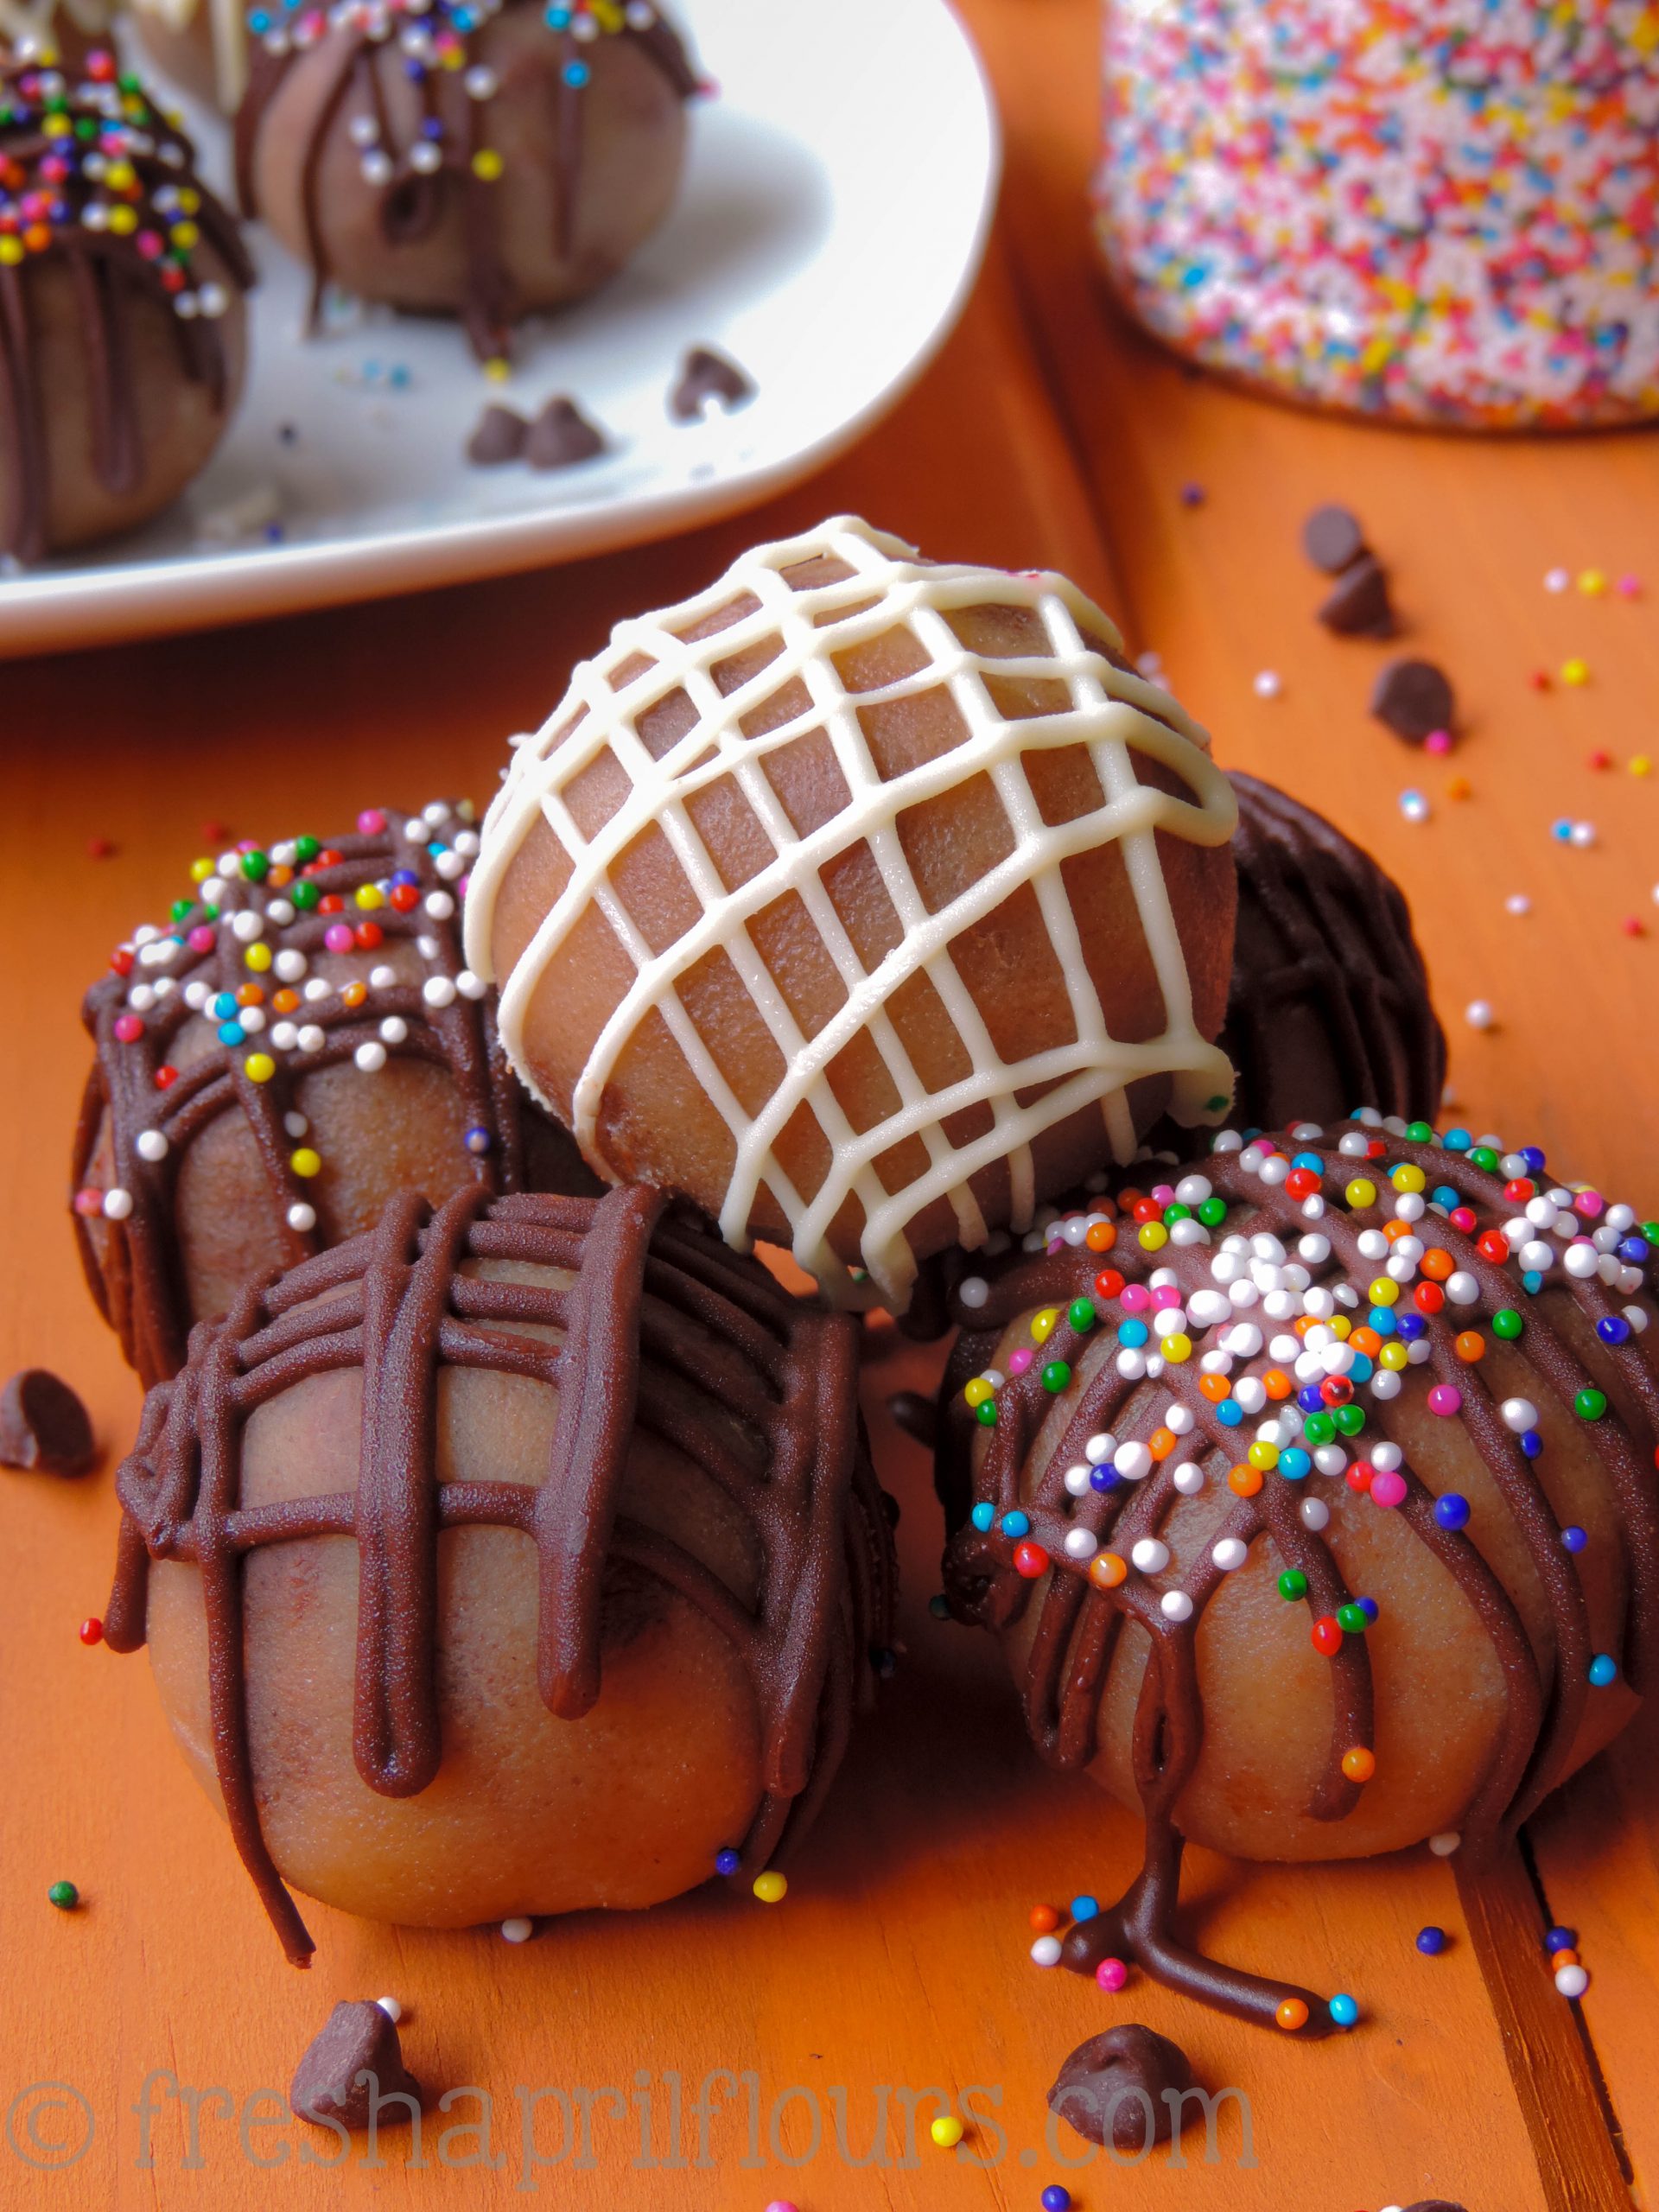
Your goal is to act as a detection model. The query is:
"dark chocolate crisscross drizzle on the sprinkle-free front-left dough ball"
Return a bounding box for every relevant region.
[104,1185,893,1964]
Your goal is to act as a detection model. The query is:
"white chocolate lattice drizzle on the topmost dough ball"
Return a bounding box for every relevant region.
[467,518,1236,1310]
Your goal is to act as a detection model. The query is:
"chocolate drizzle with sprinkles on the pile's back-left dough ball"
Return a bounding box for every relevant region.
[71,805,595,1385]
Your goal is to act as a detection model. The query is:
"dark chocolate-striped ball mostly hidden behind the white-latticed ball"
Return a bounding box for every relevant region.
[1221,774,1446,1128]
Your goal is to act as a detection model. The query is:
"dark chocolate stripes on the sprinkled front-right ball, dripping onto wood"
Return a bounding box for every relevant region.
[936,1128,1659,2037]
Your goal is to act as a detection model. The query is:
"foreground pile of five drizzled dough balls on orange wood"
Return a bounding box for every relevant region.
[73,518,1659,2035]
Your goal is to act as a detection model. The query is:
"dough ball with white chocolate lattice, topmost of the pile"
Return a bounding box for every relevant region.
[467,518,1236,1312]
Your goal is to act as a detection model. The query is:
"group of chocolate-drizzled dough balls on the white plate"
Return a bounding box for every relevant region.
[0,0,702,560]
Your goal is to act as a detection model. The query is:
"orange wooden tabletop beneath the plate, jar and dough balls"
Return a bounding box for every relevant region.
[0,0,1659,2212]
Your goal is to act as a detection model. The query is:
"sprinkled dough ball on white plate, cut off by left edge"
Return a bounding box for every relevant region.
[0,44,252,560]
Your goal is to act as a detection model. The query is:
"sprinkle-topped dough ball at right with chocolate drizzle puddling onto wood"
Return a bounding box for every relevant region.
[938,1117,1659,2033]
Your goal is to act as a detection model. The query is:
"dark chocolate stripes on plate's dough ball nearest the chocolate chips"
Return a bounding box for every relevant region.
[234,0,702,360]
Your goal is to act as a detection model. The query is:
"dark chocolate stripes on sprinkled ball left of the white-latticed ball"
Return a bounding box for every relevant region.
[71,807,526,1385]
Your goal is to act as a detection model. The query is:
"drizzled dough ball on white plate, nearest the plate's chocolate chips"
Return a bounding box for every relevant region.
[237,0,699,360]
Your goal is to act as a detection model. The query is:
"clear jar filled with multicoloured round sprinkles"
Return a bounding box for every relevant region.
[1097,0,1659,429]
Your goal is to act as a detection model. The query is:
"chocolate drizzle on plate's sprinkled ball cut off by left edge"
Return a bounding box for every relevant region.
[0,48,254,562]
